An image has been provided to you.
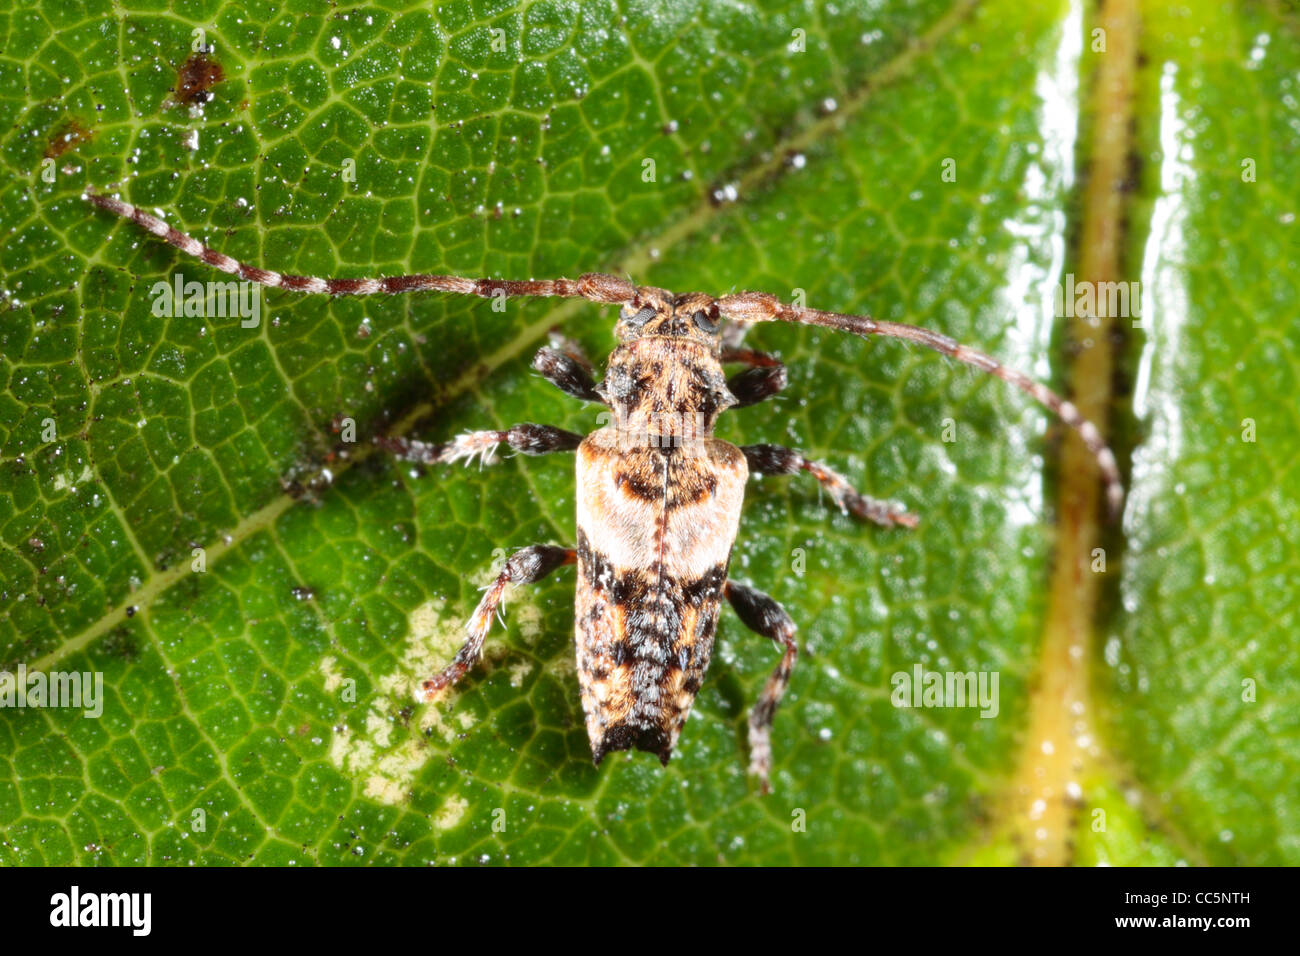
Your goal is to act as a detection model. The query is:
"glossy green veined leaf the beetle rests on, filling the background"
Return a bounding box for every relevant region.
[0,0,1300,864]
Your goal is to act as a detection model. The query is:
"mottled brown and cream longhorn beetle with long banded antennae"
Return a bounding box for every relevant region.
[86,194,1123,792]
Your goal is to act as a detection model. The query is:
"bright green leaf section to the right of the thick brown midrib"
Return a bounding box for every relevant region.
[1099,4,1300,865]
